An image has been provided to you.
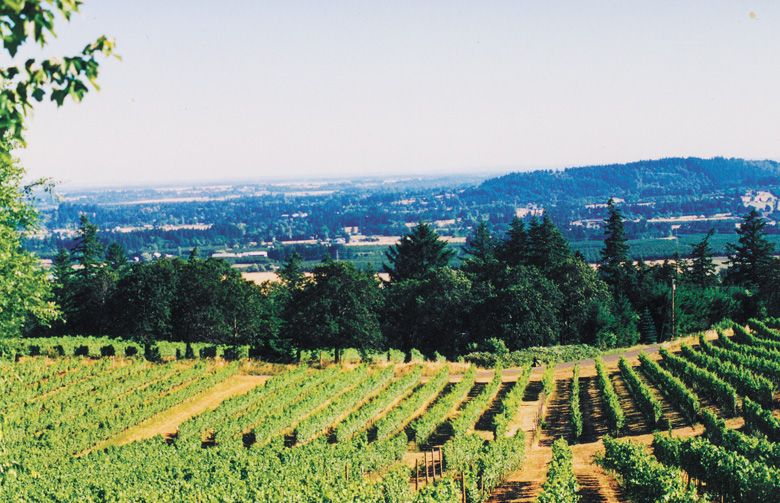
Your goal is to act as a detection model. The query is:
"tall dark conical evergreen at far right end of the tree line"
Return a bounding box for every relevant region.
[726,208,777,288]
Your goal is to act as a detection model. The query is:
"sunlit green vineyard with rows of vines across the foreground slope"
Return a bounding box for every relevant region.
[0,320,780,502]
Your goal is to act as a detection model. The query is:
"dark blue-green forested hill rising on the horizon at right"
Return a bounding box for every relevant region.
[464,157,780,206]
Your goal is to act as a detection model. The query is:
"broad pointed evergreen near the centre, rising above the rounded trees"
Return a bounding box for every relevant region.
[383,222,455,281]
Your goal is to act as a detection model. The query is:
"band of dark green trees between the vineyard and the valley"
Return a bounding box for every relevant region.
[28,201,780,360]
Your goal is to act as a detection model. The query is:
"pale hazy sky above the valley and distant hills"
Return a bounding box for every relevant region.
[13,0,780,183]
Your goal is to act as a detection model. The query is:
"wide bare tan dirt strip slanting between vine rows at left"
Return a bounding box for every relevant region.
[91,375,268,450]
